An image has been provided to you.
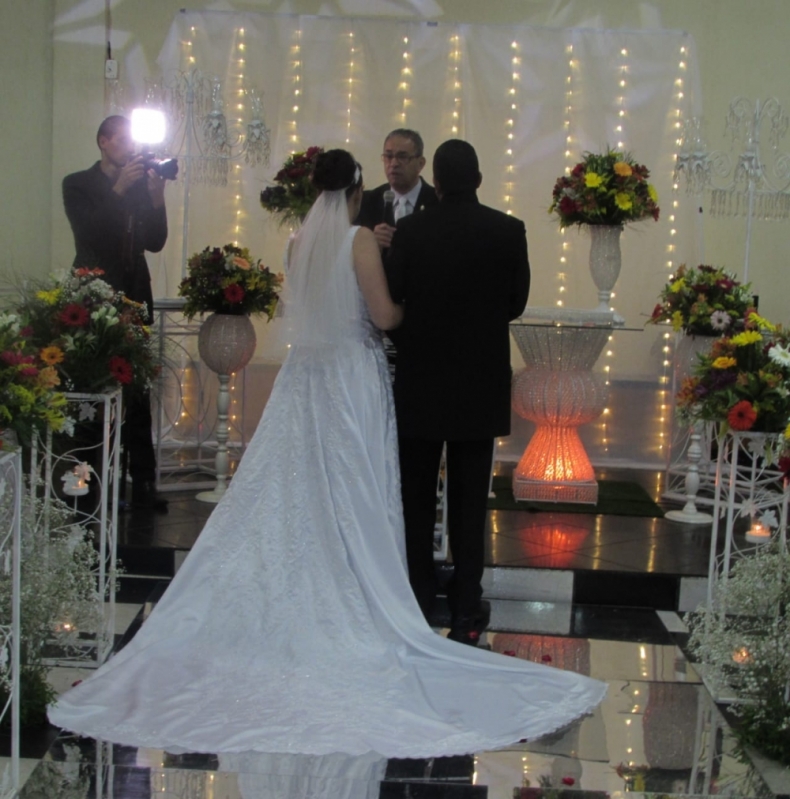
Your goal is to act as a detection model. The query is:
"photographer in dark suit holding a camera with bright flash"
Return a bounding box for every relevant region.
[63,116,167,512]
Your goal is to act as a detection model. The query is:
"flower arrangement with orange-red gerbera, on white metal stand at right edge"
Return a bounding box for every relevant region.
[677,312,790,438]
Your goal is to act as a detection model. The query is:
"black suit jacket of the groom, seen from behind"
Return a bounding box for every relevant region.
[386,193,530,441]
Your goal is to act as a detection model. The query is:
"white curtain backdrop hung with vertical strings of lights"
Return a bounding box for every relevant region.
[144,11,701,460]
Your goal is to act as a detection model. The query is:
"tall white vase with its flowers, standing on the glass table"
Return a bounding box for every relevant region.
[549,148,660,312]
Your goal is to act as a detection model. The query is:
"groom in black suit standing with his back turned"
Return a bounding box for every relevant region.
[386,139,530,643]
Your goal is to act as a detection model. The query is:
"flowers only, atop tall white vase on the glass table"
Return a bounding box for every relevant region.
[549,150,659,228]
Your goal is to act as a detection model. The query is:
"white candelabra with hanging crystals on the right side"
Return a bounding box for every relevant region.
[675,97,790,283]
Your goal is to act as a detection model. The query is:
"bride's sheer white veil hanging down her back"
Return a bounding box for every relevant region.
[283,189,359,346]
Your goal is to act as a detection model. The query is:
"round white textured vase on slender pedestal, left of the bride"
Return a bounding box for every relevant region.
[197,314,257,503]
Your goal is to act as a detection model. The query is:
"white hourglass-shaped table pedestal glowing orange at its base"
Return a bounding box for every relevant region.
[510,308,613,505]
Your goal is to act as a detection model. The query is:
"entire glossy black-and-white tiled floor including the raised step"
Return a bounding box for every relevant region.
[9,470,783,799]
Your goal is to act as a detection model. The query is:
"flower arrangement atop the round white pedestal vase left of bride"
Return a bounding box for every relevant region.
[178,244,283,319]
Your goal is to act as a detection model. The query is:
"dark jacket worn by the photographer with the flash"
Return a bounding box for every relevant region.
[63,161,167,314]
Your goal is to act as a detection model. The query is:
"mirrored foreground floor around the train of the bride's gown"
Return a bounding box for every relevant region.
[21,633,772,799]
